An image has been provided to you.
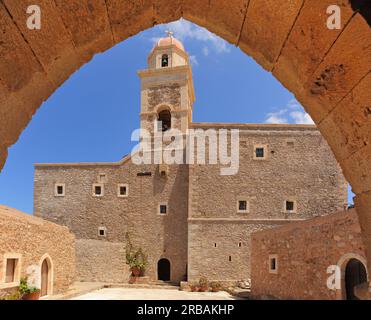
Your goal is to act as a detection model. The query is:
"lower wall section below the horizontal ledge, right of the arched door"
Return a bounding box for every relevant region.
[188,219,288,285]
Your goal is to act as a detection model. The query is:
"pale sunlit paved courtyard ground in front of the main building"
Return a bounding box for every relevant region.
[72,288,243,300]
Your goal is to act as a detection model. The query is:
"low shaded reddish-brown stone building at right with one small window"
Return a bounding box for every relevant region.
[251,210,366,300]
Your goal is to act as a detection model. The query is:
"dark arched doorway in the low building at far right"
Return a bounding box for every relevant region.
[345,259,367,300]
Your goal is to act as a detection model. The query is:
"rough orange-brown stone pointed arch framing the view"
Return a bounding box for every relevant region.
[0,0,371,278]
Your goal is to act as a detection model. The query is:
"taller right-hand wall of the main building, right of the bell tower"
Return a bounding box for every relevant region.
[188,124,347,281]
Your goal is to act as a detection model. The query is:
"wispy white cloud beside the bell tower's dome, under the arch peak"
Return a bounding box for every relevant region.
[152,19,230,56]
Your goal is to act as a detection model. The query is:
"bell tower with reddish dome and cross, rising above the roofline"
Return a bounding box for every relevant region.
[138,31,195,133]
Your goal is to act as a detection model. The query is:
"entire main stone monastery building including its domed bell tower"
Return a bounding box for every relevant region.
[34,38,347,282]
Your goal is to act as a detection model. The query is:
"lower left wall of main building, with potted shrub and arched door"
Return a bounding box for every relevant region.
[34,161,188,282]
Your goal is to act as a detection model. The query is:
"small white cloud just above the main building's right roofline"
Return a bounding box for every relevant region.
[265,99,314,124]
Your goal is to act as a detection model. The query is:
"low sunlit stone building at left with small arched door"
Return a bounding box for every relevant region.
[0,206,75,295]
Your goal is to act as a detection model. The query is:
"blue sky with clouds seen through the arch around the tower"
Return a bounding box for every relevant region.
[0,20,354,213]
